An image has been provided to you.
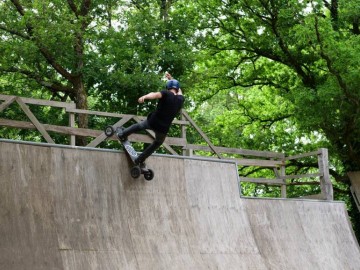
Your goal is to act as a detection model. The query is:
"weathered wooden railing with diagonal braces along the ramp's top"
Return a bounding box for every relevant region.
[0,95,333,200]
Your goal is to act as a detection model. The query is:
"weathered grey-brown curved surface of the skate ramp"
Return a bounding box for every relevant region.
[0,142,360,270]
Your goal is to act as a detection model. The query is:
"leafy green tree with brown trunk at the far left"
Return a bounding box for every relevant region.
[0,0,97,137]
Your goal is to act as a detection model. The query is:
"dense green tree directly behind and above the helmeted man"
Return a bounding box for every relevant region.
[90,0,195,114]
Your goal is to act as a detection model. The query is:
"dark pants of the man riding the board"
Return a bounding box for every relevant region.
[123,120,166,163]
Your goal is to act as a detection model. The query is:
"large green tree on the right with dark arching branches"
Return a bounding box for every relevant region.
[194,0,360,165]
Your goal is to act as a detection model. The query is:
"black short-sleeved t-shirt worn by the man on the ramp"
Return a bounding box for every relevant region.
[148,90,185,134]
